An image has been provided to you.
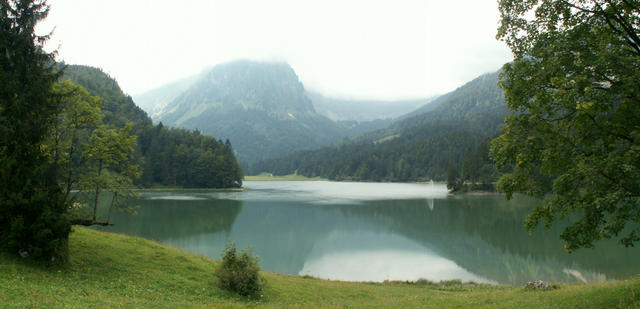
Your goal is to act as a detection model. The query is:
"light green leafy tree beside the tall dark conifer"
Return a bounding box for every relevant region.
[43,80,139,225]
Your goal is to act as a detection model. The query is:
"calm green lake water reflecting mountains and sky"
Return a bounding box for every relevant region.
[94,181,640,285]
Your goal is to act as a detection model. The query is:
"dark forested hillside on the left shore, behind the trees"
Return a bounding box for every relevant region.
[64,65,243,188]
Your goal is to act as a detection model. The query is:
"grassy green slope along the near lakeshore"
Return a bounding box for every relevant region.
[0,228,640,308]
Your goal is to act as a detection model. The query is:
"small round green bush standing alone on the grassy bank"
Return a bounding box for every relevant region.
[215,243,264,298]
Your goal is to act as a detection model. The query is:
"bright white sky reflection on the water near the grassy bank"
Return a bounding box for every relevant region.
[299,231,495,283]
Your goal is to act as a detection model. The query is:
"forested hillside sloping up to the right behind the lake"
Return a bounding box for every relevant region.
[248,73,507,181]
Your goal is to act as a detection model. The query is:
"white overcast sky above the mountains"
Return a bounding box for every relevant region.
[39,0,512,99]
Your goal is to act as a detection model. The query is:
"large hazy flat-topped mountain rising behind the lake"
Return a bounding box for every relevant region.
[144,60,390,163]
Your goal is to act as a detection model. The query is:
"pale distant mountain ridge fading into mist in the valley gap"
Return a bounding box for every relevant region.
[307,91,434,121]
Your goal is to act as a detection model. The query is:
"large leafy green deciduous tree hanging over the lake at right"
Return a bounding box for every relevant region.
[492,0,640,251]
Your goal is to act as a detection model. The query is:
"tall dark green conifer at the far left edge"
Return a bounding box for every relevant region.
[0,0,70,262]
